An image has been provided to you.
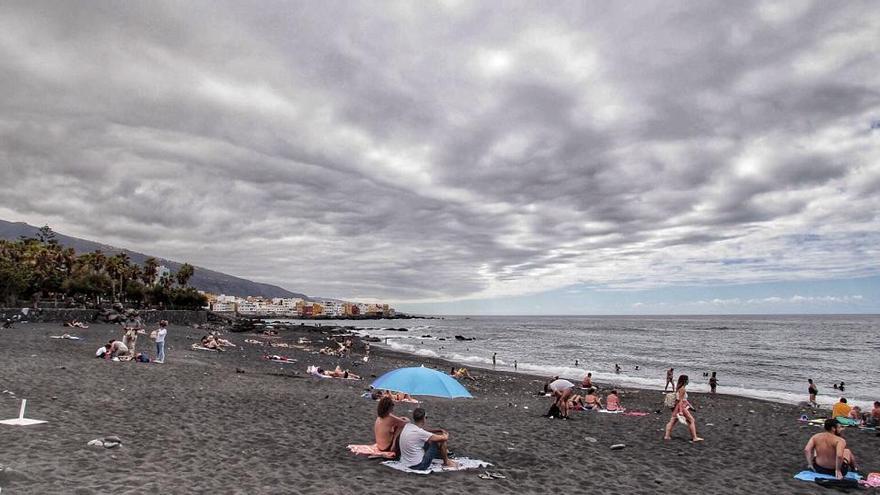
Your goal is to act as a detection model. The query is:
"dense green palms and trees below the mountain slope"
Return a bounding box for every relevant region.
[0,226,207,309]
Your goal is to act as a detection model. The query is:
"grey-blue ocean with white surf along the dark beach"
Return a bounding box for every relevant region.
[272,315,880,407]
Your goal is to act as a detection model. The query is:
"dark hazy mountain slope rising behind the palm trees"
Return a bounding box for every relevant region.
[0,220,309,299]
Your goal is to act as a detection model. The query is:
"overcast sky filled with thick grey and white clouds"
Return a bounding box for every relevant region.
[0,0,880,313]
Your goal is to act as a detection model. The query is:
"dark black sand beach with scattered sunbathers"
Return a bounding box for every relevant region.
[0,323,880,495]
